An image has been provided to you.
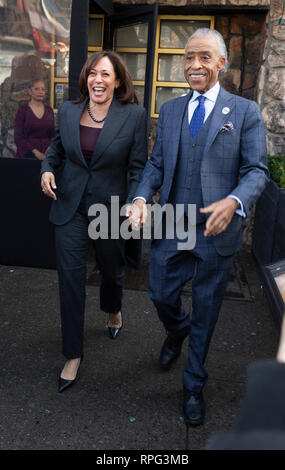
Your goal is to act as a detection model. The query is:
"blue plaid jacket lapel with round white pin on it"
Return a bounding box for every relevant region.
[204,87,235,155]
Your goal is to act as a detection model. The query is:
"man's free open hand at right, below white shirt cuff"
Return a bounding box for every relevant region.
[200,197,239,237]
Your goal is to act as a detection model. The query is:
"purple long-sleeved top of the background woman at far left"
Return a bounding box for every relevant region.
[14,103,55,158]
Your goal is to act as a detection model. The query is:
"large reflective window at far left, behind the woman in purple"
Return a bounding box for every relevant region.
[0,0,72,158]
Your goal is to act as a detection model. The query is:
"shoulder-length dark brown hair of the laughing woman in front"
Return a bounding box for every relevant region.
[77,51,138,104]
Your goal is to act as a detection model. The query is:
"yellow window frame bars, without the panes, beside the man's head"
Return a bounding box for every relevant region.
[150,15,215,118]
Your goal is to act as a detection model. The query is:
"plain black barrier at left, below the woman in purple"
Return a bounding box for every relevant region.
[0,157,55,269]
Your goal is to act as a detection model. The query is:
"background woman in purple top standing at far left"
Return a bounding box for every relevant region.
[14,79,55,160]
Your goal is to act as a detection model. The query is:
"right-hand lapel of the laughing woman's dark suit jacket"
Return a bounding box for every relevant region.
[90,99,130,166]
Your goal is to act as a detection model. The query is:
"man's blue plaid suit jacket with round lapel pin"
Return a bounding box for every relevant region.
[135,87,269,256]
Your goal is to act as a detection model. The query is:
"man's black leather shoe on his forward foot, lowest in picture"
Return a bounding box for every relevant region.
[183,388,205,426]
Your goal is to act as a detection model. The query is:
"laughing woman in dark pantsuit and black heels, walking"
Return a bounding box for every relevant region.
[41,51,147,391]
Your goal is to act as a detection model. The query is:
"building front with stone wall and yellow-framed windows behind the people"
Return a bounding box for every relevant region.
[0,0,285,158]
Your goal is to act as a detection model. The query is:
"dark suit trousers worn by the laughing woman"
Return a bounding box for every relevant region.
[55,201,125,359]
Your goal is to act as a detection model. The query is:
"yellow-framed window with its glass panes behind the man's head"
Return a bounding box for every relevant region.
[151,15,214,118]
